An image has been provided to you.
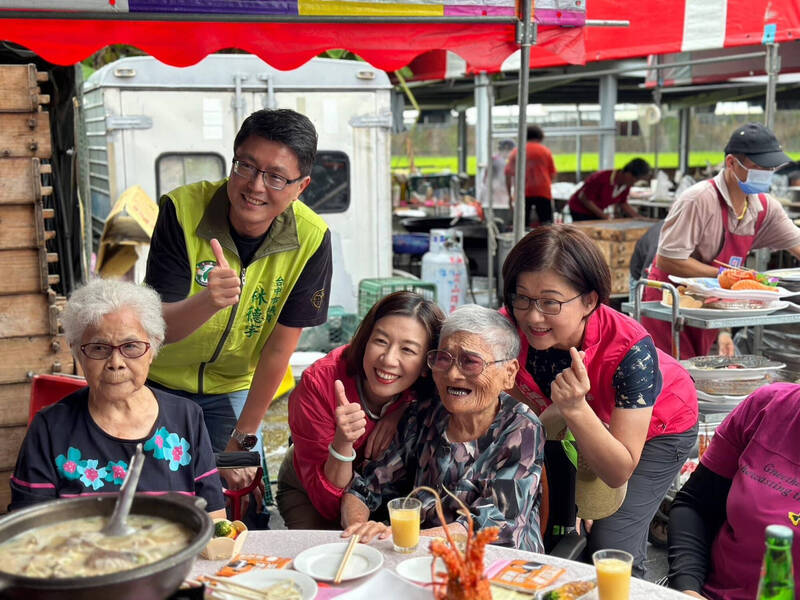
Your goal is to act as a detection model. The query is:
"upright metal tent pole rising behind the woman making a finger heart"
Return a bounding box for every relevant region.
[514,0,536,243]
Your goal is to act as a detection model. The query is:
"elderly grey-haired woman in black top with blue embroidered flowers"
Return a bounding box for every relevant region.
[9,279,225,517]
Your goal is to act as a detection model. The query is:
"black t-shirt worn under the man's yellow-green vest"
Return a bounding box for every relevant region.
[145,197,333,327]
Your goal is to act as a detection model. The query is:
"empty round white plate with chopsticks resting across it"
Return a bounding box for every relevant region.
[294,542,383,581]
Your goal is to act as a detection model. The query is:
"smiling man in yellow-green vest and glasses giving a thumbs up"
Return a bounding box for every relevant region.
[145,109,332,506]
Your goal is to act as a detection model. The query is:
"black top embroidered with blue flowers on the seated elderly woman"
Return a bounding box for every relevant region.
[9,387,225,512]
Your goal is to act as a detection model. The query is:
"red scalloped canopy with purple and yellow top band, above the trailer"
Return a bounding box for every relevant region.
[0,0,585,72]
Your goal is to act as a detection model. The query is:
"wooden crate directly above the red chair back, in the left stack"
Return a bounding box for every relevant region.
[0,335,75,384]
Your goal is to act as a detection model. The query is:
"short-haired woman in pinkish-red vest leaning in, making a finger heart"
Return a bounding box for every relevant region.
[503,225,697,577]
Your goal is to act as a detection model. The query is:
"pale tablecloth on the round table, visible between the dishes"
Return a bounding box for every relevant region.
[191,530,687,600]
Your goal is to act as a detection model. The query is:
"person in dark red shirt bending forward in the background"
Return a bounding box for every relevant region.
[569,158,650,221]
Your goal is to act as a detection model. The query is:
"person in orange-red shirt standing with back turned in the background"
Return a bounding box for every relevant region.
[506,125,556,225]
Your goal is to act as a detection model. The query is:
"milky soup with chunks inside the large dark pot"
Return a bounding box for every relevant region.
[0,515,194,579]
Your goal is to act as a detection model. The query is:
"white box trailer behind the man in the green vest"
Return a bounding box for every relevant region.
[80,54,392,312]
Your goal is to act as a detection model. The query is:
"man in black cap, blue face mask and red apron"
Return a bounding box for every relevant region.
[642,123,800,358]
